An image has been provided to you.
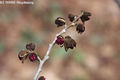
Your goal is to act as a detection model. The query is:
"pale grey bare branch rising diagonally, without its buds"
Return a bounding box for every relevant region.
[33,11,83,80]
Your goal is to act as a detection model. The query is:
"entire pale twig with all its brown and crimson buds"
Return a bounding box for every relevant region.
[18,11,91,80]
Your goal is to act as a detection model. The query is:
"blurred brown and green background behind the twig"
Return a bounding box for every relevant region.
[0,0,120,80]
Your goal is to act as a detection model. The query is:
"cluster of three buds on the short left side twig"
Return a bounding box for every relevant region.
[18,43,38,63]
